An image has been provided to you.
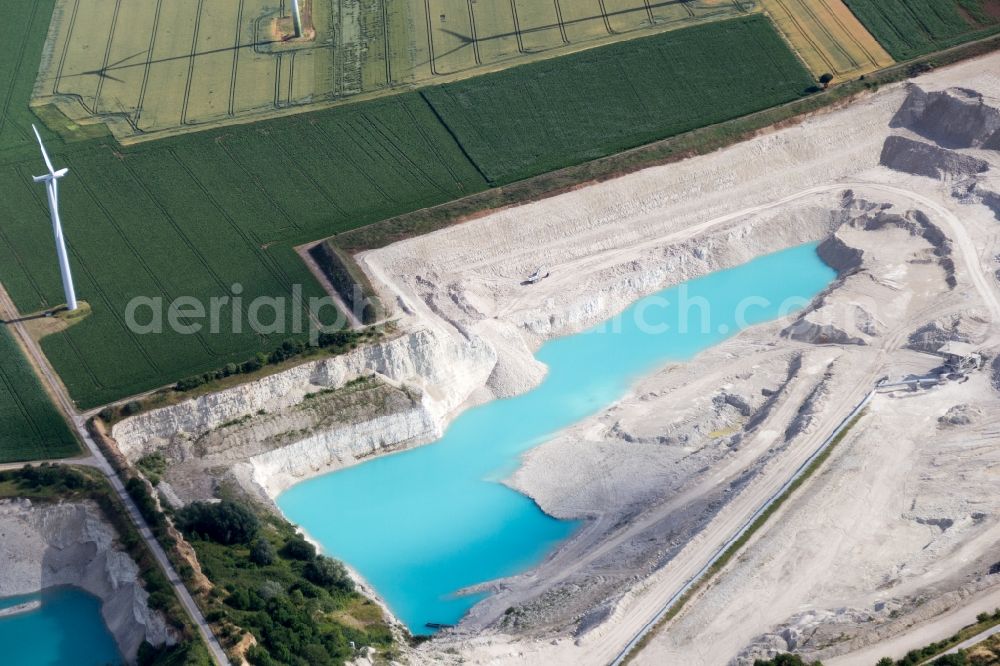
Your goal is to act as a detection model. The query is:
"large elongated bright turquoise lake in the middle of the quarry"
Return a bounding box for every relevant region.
[278,244,835,634]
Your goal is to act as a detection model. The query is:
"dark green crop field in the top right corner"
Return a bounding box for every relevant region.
[845,0,1000,60]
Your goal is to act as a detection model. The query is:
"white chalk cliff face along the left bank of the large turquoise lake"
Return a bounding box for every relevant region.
[112,326,497,499]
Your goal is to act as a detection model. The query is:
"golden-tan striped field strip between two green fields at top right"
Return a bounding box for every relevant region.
[761,0,893,81]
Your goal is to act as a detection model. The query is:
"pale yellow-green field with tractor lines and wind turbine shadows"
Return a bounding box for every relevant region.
[35,0,757,142]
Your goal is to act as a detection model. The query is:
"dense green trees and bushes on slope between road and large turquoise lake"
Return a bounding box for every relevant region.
[177,501,393,666]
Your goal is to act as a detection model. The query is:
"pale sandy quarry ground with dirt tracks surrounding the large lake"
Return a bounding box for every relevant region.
[352,55,1000,665]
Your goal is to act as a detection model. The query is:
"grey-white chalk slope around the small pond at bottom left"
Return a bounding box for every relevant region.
[0,500,176,662]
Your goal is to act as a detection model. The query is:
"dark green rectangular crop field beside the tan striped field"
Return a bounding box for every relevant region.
[422,15,814,183]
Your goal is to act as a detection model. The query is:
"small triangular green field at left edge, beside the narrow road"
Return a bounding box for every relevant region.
[0,324,80,463]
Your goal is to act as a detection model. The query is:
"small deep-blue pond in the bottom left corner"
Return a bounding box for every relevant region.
[0,587,124,666]
